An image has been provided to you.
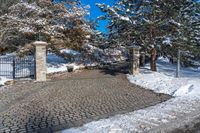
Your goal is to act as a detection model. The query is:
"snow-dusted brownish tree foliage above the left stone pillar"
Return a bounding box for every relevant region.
[0,0,93,52]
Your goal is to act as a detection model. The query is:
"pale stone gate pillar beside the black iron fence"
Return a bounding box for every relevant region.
[33,41,47,82]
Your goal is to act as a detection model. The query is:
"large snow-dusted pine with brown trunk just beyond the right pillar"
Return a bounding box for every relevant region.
[96,0,171,71]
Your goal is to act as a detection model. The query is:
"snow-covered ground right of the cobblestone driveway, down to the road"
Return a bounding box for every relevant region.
[61,58,200,133]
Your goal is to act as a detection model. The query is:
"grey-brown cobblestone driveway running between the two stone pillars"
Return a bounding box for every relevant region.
[0,70,170,133]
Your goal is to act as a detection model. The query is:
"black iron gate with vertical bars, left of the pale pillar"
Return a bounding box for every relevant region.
[0,56,35,79]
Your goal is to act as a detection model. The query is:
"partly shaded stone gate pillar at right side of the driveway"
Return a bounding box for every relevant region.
[129,46,140,75]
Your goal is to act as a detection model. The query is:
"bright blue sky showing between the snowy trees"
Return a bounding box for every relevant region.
[81,0,115,32]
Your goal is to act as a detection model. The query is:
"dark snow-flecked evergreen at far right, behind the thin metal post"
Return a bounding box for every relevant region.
[164,0,200,64]
